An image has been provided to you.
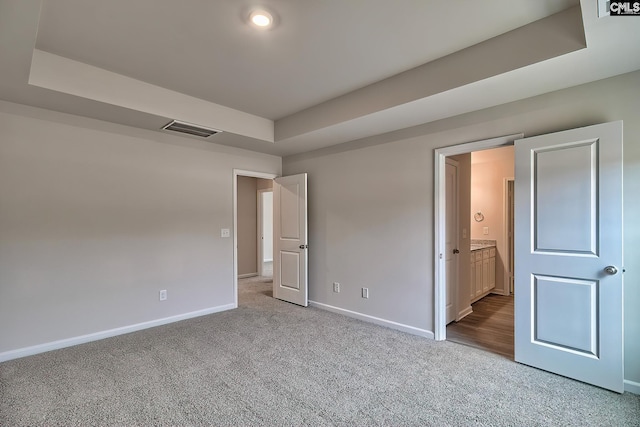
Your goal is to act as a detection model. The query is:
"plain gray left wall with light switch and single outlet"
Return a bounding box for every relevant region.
[0,102,281,356]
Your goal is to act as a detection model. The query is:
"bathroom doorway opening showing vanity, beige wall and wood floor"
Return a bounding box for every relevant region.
[445,146,514,359]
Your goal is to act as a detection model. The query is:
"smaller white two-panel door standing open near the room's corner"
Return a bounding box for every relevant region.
[273,173,308,307]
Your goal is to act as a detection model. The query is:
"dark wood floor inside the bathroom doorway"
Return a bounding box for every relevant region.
[447,295,513,360]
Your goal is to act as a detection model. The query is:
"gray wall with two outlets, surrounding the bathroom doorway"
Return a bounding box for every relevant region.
[283,72,640,383]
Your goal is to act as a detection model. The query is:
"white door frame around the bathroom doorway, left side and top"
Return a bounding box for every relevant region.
[433,133,524,341]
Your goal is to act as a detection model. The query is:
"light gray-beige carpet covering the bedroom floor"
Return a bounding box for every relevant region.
[0,278,640,426]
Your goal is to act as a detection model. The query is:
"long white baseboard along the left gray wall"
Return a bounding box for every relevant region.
[0,304,237,362]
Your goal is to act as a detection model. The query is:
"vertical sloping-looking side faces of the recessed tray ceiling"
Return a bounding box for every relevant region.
[29,7,586,149]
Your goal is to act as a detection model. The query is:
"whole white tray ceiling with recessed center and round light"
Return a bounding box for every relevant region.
[0,0,640,155]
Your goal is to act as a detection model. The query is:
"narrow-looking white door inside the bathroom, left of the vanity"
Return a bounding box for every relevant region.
[445,159,459,324]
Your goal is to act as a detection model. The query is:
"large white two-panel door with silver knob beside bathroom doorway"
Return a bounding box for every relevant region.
[515,122,623,393]
